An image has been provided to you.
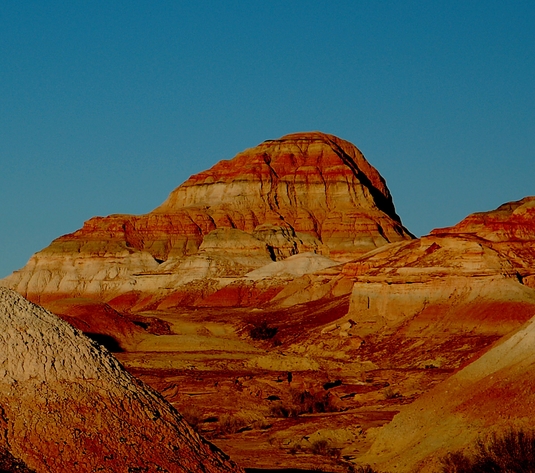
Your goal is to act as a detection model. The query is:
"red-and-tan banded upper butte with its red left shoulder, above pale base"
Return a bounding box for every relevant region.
[56,133,410,260]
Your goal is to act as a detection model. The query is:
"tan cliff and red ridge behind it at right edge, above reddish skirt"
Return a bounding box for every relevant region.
[343,197,535,335]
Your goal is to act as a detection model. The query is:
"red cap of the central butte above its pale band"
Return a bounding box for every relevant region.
[154,132,399,216]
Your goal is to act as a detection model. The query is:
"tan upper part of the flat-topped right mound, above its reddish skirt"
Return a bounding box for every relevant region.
[343,231,533,336]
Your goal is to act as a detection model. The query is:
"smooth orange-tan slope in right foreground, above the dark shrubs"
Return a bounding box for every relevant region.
[361,312,535,472]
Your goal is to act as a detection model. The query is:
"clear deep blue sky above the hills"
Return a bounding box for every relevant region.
[0,0,535,277]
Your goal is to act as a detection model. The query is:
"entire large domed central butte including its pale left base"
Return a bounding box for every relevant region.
[3,132,412,304]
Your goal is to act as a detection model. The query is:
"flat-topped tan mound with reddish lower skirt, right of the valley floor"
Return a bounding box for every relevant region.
[280,230,535,384]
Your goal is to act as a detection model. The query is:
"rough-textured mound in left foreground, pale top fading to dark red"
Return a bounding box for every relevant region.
[0,288,241,473]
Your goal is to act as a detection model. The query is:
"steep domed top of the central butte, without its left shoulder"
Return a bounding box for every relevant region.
[152,132,411,259]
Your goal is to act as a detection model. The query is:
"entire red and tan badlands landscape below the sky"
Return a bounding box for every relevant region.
[0,132,535,472]
